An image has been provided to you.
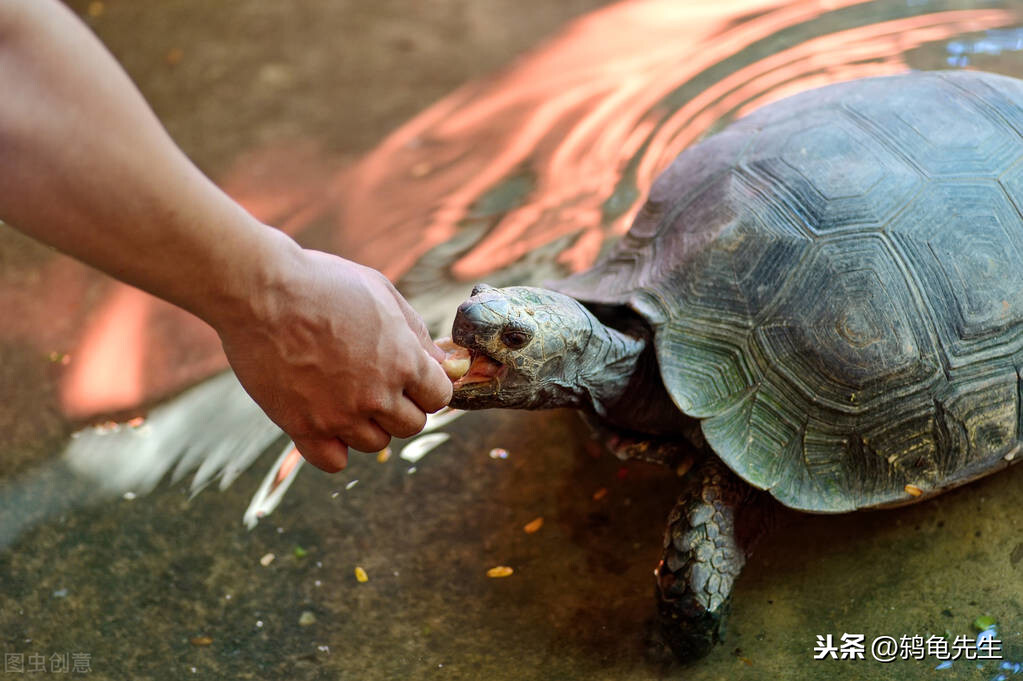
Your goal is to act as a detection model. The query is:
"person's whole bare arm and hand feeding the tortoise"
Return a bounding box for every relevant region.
[0,0,451,471]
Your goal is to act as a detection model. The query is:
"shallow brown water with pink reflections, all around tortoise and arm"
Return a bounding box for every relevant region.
[0,0,1023,680]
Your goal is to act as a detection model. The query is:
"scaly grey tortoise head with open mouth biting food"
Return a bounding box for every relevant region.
[451,284,641,411]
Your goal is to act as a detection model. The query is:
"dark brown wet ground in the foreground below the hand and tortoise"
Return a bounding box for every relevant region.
[0,402,1023,680]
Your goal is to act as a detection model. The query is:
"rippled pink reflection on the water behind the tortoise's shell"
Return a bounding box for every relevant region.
[339,0,1014,280]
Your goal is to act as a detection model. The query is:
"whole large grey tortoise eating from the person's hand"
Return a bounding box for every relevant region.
[443,72,1023,659]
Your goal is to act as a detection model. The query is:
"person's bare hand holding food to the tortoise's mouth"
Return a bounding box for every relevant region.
[210,240,451,472]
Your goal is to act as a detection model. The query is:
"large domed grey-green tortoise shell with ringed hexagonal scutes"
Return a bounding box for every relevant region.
[555,72,1023,512]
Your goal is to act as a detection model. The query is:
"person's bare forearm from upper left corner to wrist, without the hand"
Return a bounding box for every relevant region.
[0,0,297,325]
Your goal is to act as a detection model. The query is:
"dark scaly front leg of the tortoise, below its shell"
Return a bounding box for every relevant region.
[655,454,774,660]
